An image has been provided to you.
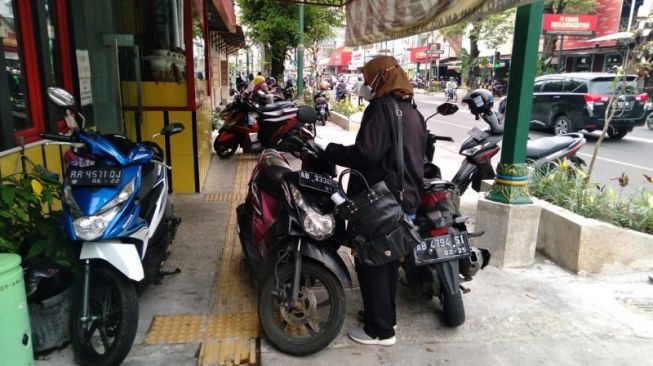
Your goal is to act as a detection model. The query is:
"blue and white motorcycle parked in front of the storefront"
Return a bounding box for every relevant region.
[42,88,184,366]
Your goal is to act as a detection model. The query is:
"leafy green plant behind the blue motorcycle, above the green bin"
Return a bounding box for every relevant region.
[0,173,73,266]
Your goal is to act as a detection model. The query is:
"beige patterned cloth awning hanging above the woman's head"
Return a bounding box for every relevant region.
[345,0,535,46]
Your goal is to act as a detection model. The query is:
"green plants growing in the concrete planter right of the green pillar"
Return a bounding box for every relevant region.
[529,161,653,234]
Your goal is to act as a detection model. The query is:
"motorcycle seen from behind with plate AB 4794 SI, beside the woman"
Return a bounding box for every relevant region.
[402,103,490,327]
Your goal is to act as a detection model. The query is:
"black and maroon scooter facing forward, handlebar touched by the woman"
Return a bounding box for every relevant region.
[237,107,351,355]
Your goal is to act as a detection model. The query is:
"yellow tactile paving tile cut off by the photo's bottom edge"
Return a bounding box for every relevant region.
[198,337,258,366]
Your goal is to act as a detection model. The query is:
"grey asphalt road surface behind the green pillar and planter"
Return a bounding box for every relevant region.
[415,95,653,196]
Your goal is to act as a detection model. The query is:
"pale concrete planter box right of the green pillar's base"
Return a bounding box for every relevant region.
[535,200,653,273]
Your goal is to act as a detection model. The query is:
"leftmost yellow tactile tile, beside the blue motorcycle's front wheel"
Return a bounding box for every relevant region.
[145,315,207,344]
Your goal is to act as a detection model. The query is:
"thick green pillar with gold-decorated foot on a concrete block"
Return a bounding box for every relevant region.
[487,0,544,204]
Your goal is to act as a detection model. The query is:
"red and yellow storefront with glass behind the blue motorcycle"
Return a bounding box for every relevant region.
[0,0,244,192]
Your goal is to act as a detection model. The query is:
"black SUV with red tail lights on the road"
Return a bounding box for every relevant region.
[530,73,648,140]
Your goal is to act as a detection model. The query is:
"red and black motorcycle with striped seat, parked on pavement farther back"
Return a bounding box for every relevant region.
[213,98,298,159]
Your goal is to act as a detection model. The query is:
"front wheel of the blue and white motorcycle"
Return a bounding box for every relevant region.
[70,266,138,366]
